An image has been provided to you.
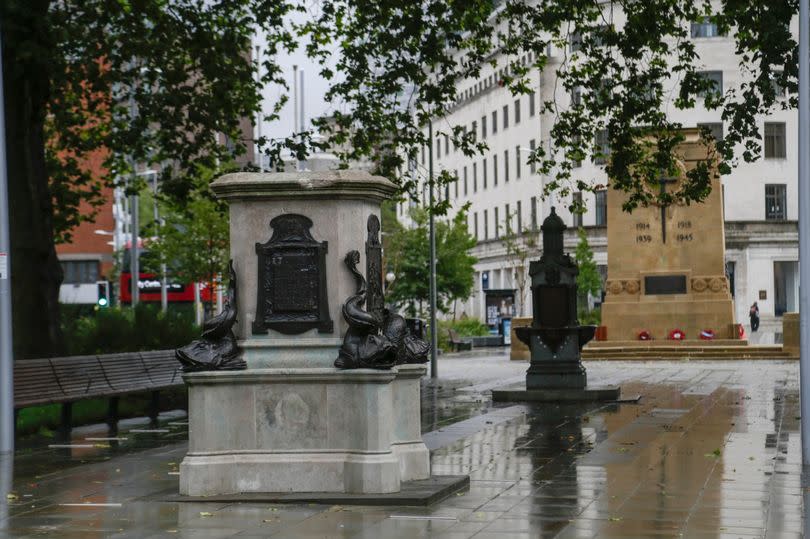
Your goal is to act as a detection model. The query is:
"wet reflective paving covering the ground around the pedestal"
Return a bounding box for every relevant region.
[0,352,804,539]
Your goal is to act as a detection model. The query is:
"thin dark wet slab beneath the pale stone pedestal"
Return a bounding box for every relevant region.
[164,475,470,507]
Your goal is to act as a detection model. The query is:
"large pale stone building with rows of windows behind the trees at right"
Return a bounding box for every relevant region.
[398,5,798,342]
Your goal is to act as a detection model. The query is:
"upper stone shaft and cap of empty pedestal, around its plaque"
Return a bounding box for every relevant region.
[211,170,396,368]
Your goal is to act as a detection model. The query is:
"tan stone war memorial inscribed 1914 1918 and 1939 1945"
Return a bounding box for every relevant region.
[602,129,736,341]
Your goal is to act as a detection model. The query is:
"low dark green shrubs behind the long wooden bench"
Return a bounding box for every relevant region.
[63,303,200,356]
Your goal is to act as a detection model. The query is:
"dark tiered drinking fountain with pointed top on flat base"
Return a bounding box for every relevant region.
[492,208,619,401]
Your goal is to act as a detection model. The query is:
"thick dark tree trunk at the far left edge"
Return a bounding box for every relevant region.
[0,0,62,359]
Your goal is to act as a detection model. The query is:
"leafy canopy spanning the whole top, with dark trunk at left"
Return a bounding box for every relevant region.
[0,0,798,356]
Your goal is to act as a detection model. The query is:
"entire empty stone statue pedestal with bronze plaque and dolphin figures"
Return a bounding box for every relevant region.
[172,170,460,505]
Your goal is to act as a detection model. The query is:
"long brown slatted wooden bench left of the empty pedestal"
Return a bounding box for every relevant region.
[14,350,183,436]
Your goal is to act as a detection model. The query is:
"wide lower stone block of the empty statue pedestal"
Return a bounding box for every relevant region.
[180,365,430,496]
